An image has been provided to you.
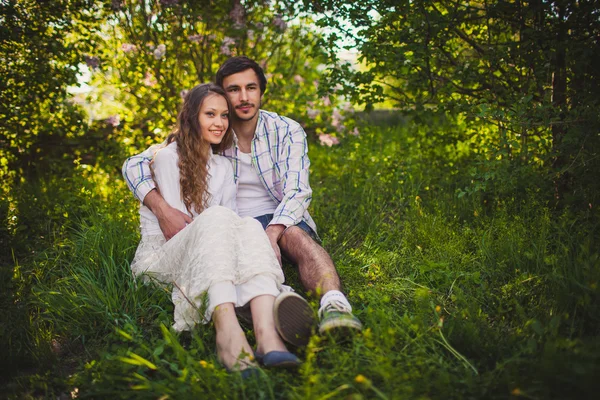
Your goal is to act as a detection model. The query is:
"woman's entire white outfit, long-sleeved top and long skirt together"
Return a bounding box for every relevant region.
[131,142,284,331]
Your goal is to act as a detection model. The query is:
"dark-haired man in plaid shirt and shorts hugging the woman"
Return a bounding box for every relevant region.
[123,57,362,345]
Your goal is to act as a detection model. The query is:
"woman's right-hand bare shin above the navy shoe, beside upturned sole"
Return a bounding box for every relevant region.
[250,295,287,354]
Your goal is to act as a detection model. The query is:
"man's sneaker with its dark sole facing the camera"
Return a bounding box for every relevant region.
[273,292,317,347]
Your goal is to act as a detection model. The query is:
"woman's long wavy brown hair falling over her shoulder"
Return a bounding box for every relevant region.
[167,83,233,213]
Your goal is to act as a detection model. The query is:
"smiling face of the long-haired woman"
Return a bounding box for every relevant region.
[199,93,229,144]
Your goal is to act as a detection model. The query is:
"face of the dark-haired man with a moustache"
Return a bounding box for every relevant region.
[223,69,262,121]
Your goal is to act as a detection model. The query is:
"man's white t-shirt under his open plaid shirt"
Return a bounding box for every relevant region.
[237,151,278,217]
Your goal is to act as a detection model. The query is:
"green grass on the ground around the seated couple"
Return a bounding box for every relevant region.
[5,120,600,399]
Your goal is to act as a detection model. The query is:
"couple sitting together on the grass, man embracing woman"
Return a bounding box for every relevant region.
[123,57,362,375]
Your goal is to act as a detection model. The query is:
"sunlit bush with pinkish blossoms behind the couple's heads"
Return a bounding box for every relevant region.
[78,0,352,151]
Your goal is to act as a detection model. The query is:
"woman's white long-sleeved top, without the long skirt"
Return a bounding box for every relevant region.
[140,142,237,235]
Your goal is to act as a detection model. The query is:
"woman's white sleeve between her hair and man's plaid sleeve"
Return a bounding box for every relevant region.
[151,147,191,216]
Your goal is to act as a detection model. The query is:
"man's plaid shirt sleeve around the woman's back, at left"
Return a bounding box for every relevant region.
[122,143,165,203]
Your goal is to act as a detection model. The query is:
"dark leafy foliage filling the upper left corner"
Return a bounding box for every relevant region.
[0,0,102,181]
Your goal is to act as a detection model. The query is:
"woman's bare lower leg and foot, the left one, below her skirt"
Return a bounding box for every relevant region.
[212,303,255,371]
